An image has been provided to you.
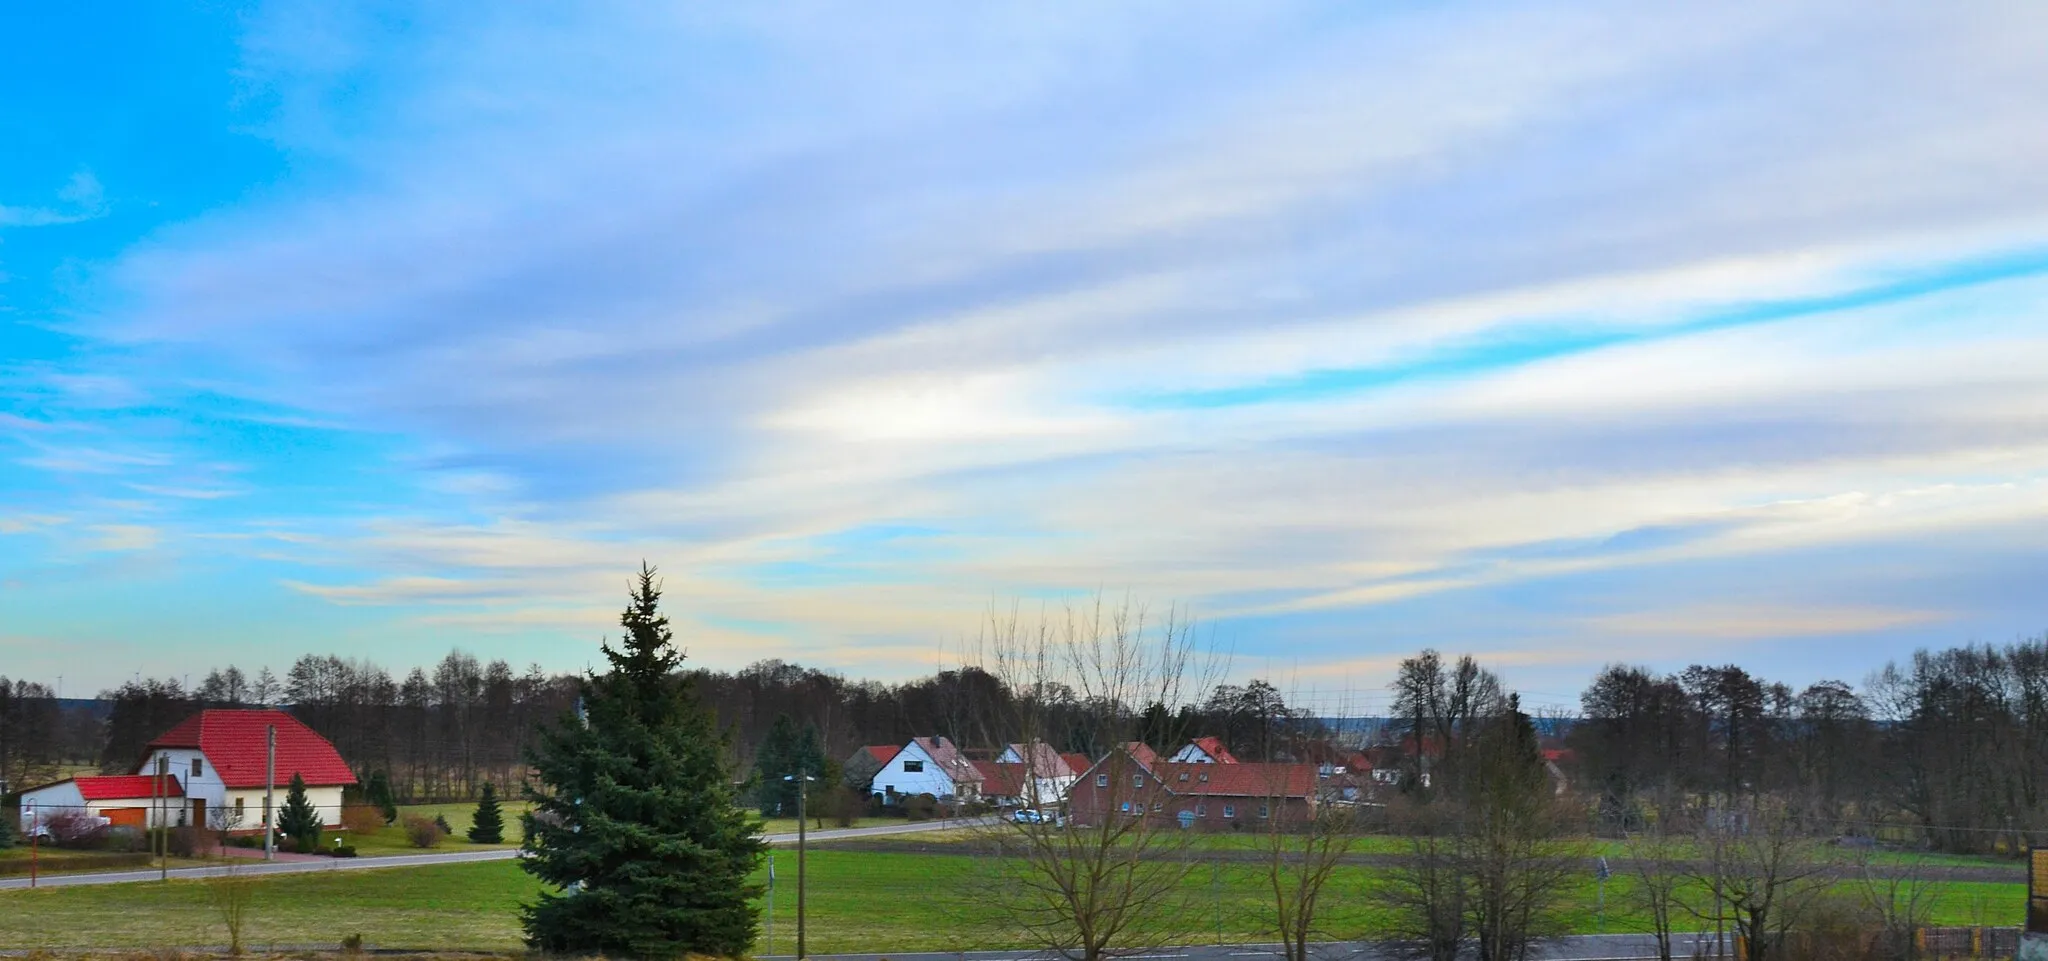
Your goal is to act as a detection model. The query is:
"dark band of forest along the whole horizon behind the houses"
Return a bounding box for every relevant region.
[0,637,2048,850]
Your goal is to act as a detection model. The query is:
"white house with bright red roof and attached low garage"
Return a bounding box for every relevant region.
[20,709,356,830]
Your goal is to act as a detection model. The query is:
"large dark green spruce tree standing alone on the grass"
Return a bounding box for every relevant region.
[520,563,766,957]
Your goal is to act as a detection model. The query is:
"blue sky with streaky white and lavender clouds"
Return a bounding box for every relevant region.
[0,0,2048,711]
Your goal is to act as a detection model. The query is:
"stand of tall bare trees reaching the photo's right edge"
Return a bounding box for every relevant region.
[1569,635,2048,852]
